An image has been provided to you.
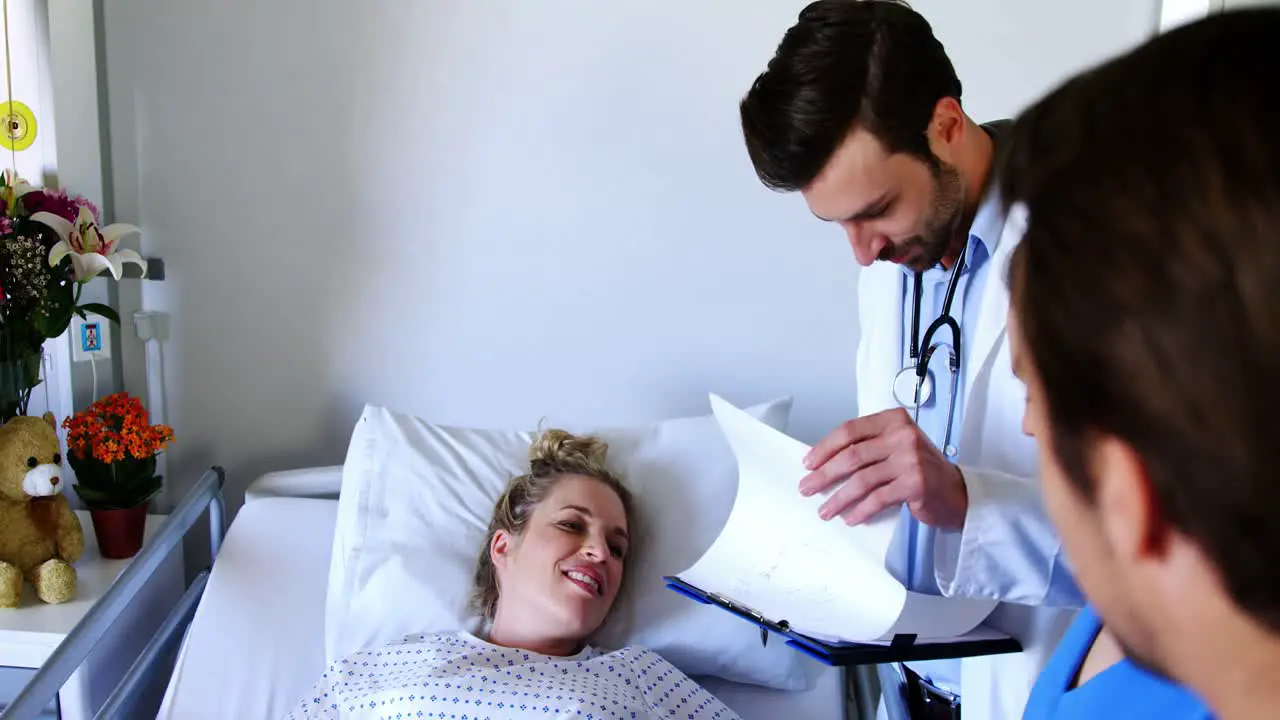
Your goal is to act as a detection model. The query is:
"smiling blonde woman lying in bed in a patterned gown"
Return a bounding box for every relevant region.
[289,430,737,720]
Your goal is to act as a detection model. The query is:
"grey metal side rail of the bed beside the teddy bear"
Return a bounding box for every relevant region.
[0,465,227,720]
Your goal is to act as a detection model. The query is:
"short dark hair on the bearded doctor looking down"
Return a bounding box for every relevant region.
[739,0,961,191]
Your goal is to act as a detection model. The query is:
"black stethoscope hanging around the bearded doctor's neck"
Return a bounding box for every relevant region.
[893,240,968,457]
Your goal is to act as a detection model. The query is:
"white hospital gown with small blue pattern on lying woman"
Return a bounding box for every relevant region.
[288,633,740,720]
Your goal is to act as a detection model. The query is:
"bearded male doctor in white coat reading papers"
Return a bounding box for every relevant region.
[741,0,1083,720]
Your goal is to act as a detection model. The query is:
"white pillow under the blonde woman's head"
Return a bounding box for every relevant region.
[325,397,808,689]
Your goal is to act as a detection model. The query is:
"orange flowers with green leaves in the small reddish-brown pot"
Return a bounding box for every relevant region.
[63,392,173,510]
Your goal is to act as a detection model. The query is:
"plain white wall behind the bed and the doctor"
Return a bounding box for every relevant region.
[94,0,1158,515]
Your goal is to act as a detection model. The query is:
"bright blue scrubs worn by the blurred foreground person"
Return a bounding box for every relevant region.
[1023,607,1213,720]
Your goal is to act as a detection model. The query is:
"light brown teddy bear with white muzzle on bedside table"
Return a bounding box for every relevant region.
[0,413,84,607]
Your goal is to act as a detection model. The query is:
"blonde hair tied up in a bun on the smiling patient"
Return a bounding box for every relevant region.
[471,429,632,623]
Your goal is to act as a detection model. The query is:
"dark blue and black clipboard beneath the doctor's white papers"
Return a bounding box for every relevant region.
[663,575,1023,667]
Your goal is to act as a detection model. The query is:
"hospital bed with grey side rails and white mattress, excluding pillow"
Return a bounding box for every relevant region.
[0,466,858,720]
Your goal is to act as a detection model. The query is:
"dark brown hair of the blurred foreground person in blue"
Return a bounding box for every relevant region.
[998,9,1280,630]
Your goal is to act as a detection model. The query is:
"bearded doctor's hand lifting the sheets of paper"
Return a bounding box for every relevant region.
[800,407,969,529]
